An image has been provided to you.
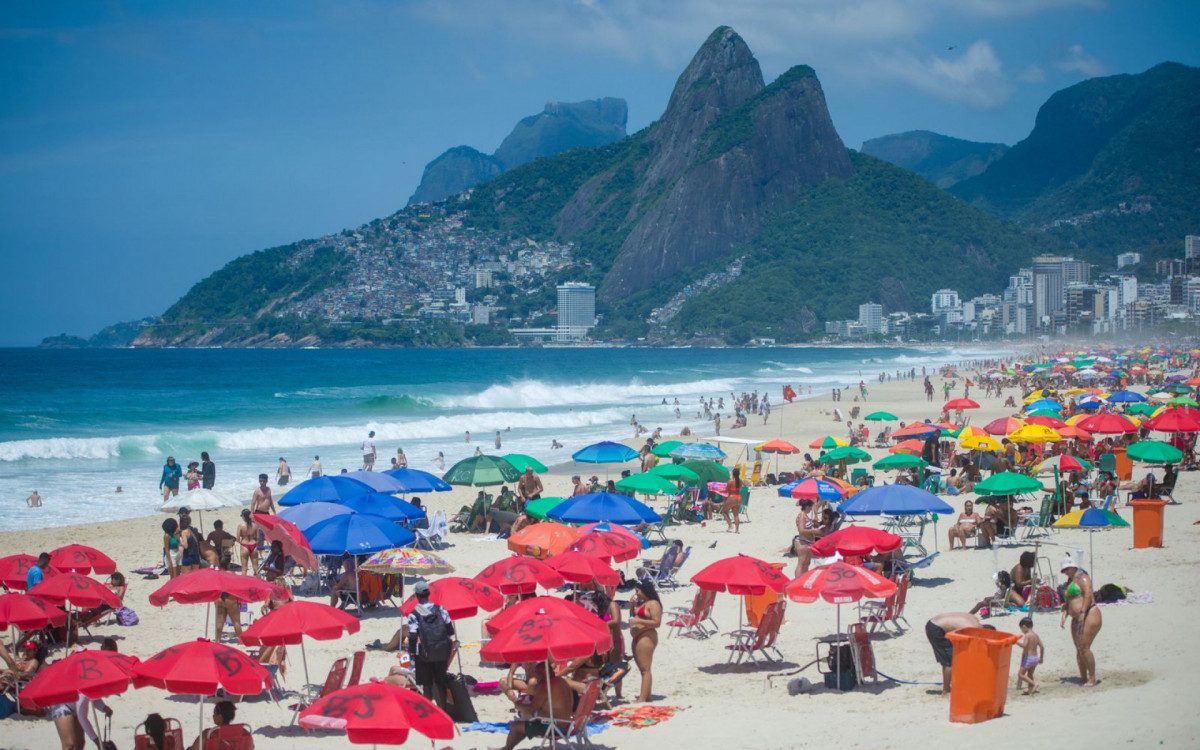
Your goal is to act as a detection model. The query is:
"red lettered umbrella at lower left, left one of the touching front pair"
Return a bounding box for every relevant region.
[20,649,138,708]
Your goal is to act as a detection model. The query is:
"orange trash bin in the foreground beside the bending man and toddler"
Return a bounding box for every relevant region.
[946,628,1021,724]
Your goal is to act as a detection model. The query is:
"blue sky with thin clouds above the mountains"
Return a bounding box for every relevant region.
[0,0,1200,346]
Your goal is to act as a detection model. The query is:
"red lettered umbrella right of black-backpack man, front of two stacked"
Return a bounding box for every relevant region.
[479,613,612,662]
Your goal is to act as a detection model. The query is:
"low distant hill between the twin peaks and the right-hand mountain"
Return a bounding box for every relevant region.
[863,131,1008,190]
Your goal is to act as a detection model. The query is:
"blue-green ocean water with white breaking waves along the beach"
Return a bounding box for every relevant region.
[0,348,1001,530]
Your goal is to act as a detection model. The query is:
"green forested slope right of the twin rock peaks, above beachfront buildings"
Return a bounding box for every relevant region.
[677,152,1060,341]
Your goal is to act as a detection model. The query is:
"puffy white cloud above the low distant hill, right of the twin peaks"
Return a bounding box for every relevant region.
[874,40,1013,109]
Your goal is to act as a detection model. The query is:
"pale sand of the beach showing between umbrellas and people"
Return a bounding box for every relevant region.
[0,378,1200,750]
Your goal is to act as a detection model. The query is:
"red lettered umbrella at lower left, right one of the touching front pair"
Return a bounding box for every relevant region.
[133,638,271,695]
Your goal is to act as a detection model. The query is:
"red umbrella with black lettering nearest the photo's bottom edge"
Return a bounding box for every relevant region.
[300,682,455,745]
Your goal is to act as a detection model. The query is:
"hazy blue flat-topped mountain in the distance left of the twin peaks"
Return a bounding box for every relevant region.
[408,97,629,205]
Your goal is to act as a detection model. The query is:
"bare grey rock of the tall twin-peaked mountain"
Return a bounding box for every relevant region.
[600,43,854,301]
